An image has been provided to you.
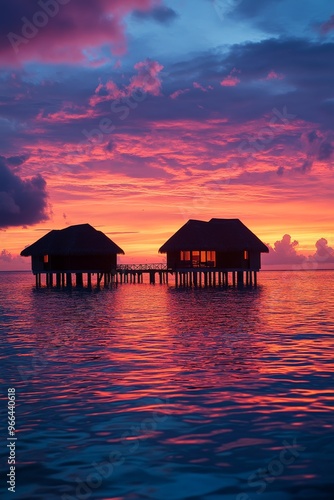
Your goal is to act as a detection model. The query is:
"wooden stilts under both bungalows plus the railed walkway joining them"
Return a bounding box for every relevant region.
[35,263,257,288]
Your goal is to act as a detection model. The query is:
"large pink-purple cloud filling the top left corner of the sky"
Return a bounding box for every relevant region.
[0,0,161,66]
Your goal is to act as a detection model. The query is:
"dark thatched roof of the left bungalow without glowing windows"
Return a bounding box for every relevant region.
[21,224,124,257]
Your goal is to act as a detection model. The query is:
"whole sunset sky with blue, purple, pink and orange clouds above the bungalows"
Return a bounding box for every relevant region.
[0,0,334,270]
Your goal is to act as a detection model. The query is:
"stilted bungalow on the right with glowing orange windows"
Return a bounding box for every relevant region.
[159,219,269,284]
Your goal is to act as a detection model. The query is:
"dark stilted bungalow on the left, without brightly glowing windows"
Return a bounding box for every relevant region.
[21,224,124,287]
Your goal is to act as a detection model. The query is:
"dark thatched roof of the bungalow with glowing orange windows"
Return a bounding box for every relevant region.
[159,219,269,253]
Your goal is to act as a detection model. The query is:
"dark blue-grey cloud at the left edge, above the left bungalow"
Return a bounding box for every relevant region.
[0,156,49,228]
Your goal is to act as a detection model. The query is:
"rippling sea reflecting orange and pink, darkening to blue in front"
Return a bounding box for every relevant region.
[0,271,334,500]
